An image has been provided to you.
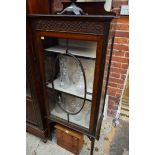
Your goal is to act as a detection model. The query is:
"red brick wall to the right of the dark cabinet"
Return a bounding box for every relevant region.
[108,0,129,115]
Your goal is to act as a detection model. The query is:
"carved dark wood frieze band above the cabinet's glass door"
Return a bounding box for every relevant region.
[32,19,107,35]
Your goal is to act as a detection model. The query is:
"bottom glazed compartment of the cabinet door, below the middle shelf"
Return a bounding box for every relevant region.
[48,93,91,128]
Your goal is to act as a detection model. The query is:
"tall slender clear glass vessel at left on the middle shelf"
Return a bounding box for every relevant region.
[59,56,70,89]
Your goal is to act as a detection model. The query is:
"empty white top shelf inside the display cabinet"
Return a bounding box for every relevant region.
[44,45,96,59]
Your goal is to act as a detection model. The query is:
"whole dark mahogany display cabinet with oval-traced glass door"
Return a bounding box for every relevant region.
[27,2,115,154]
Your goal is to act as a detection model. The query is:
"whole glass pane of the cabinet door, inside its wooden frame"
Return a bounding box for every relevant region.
[42,37,97,128]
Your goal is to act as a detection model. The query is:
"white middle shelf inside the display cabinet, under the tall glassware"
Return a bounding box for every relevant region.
[47,79,92,101]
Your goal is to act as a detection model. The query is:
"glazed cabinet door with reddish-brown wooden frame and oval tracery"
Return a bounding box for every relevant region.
[36,32,105,134]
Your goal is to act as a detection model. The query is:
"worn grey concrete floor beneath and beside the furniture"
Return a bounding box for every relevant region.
[26,117,129,155]
